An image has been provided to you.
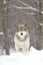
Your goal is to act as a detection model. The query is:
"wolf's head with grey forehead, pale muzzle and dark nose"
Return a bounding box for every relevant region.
[16,24,28,40]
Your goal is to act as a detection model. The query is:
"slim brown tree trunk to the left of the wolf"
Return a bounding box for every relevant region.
[2,0,9,55]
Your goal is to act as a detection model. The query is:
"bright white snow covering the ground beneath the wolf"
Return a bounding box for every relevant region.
[0,47,43,65]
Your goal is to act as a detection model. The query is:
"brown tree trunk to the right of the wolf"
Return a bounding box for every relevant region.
[35,0,42,50]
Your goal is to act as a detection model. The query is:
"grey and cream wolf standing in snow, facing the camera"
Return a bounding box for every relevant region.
[14,24,30,53]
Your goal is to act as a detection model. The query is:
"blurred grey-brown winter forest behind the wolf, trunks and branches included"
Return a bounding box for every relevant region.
[0,0,43,54]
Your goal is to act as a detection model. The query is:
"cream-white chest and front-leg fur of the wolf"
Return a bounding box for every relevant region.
[14,36,30,52]
